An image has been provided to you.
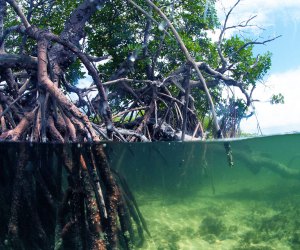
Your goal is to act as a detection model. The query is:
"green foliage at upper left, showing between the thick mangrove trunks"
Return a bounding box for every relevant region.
[5,0,84,77]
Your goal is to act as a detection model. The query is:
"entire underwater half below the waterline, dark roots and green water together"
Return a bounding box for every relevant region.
[0,134,300,250]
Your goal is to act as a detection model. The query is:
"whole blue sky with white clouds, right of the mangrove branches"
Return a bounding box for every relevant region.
[217,0,300,135]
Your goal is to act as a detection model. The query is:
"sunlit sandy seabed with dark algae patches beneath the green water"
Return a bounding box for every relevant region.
[137,173,300,250]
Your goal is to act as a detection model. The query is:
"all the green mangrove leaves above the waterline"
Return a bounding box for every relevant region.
[1,0,274,137]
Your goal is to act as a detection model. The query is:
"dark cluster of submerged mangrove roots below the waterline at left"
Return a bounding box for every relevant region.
[0,144,149,250]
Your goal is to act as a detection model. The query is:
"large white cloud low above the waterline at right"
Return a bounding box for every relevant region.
[241,67,300,134]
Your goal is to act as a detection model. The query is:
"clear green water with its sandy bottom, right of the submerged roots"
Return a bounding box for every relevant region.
[106,134,300,250]
